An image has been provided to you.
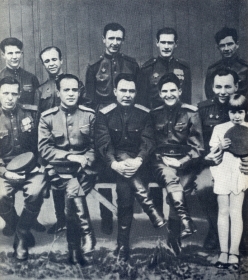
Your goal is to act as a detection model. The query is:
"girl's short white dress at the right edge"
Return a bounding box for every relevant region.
[209,121,248,195]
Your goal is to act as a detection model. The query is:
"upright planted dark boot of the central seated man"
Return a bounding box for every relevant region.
[116,207,133,262]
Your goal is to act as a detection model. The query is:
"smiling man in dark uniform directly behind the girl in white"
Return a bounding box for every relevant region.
[197,68,248,254]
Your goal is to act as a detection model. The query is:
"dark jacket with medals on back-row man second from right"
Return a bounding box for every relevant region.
[137,56,191,109]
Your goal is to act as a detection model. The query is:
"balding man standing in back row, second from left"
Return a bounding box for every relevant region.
[37,46,85,234]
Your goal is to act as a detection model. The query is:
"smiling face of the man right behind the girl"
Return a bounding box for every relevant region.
[213,74,238,103]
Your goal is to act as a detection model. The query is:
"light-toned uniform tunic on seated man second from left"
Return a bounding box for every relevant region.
[38,105,95,195]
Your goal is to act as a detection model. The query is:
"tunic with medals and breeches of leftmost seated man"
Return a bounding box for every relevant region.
[0,104,46,214]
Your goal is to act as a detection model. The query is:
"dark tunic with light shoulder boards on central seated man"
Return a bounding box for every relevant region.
[95,103,155,166]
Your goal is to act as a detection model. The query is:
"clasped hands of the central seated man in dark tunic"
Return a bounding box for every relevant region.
[111,157,143,178]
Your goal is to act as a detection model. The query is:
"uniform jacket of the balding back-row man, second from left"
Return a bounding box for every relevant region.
[36,78,85,113]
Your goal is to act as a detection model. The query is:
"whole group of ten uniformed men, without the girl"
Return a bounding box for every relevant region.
[0,23,248,265]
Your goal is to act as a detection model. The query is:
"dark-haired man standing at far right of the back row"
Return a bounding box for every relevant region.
[205,27,248,99]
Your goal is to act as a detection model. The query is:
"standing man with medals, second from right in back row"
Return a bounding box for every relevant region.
[137,27,192,109]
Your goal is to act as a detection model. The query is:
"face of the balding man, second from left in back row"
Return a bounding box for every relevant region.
[41,49,63,76]
